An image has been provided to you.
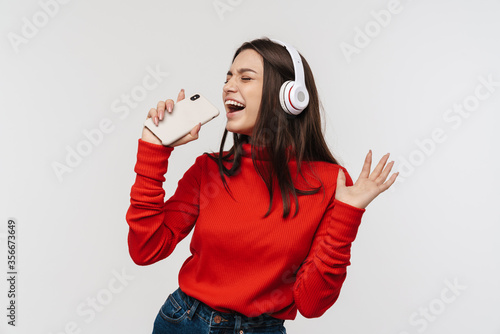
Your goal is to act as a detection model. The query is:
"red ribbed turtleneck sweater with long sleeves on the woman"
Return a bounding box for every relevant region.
[126,139,365,320]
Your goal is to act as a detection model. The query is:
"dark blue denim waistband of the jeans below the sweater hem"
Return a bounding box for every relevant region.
[172,288,285,329]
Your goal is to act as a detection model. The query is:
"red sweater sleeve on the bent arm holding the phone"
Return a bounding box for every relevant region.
[126,139,201,265]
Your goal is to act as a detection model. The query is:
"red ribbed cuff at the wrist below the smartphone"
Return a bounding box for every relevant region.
[134,138,174,182]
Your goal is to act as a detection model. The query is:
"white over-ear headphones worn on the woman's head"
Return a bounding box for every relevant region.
[271,39,309,115]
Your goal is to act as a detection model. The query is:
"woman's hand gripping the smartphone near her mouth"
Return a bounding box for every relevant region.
[142,89,201,147]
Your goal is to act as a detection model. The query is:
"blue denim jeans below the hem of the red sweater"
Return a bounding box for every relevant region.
[153,288,286,334]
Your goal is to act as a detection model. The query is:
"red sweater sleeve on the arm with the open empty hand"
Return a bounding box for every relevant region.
[293,167,365,318]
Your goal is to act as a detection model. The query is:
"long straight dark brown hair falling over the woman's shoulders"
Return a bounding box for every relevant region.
[205,37,338,218]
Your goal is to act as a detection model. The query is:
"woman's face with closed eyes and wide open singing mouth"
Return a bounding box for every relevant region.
[222,49,264,136]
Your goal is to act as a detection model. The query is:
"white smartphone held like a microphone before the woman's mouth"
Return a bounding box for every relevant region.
[144,94,219,146]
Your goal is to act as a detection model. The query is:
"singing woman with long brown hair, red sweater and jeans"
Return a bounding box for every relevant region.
[126,38,398,333]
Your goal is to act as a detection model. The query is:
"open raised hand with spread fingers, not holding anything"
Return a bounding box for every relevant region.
[335,150,399,209]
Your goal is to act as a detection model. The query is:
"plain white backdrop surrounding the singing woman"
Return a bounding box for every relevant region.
[0,0,500,334]
